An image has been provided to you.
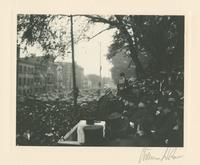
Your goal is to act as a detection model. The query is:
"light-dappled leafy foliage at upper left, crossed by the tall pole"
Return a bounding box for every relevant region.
[17,14,89,59]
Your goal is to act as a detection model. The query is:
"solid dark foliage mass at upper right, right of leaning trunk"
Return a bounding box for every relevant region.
[136,16,184,73]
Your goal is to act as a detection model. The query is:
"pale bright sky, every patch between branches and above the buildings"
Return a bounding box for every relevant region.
[19,15,116,77]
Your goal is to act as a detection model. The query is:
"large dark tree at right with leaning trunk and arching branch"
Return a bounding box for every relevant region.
[86,15,184,78]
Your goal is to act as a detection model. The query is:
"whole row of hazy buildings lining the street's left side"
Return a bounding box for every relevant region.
[17,45,85,96]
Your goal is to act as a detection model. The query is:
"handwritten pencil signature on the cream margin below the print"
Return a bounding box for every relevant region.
[138,148,183,163]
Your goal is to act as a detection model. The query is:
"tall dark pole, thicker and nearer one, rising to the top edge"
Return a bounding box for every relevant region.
[70,15,78,105]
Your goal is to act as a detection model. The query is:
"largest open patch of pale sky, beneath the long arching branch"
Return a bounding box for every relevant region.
[75,27,113,77]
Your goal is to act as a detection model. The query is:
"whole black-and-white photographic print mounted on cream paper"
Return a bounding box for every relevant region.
[15,13,185,147]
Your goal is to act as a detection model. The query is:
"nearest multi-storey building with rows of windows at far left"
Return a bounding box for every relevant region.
[17,50,56,95]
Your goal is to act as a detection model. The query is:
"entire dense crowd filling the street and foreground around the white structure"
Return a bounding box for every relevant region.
[16,71,184,146]
